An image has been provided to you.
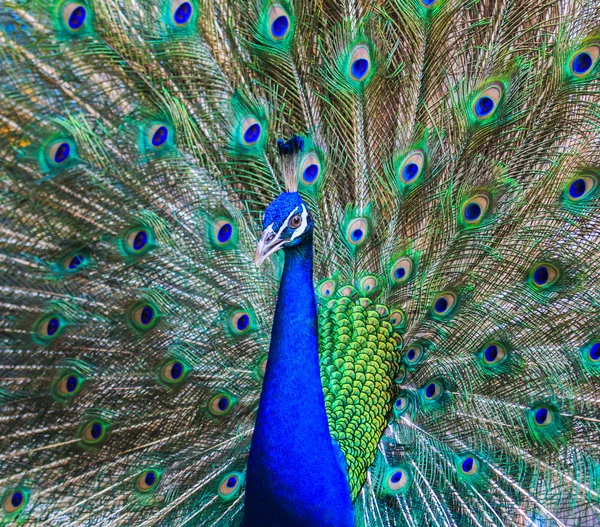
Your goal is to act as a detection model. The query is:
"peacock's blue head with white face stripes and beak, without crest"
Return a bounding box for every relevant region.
[254,192,314,265]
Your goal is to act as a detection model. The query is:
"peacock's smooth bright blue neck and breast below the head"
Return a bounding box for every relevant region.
[244,238,354,527]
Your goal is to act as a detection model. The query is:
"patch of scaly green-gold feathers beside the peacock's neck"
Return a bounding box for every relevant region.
[319,286,402,499]
